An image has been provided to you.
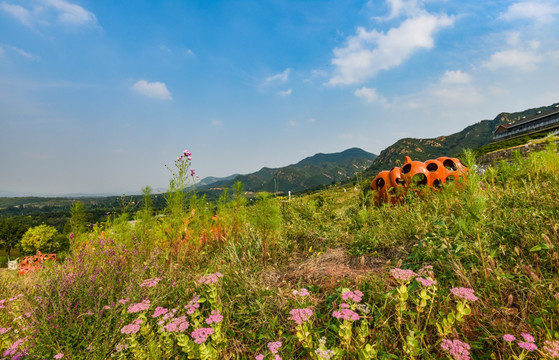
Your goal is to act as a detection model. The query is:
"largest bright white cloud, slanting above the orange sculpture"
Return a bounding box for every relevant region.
[327,11,454,85]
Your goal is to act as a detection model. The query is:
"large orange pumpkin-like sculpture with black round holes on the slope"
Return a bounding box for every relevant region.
[371,156,468,204]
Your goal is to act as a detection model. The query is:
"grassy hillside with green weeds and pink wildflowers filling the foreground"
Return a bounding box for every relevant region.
[0,142,559,360]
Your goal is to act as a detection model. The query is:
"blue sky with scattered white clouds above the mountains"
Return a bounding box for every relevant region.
[0,0,559,194]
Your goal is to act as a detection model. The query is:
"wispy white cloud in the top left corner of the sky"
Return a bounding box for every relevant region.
[0,0,98,27]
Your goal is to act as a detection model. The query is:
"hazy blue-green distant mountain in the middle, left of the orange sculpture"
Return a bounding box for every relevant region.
[197,148,377,193]
